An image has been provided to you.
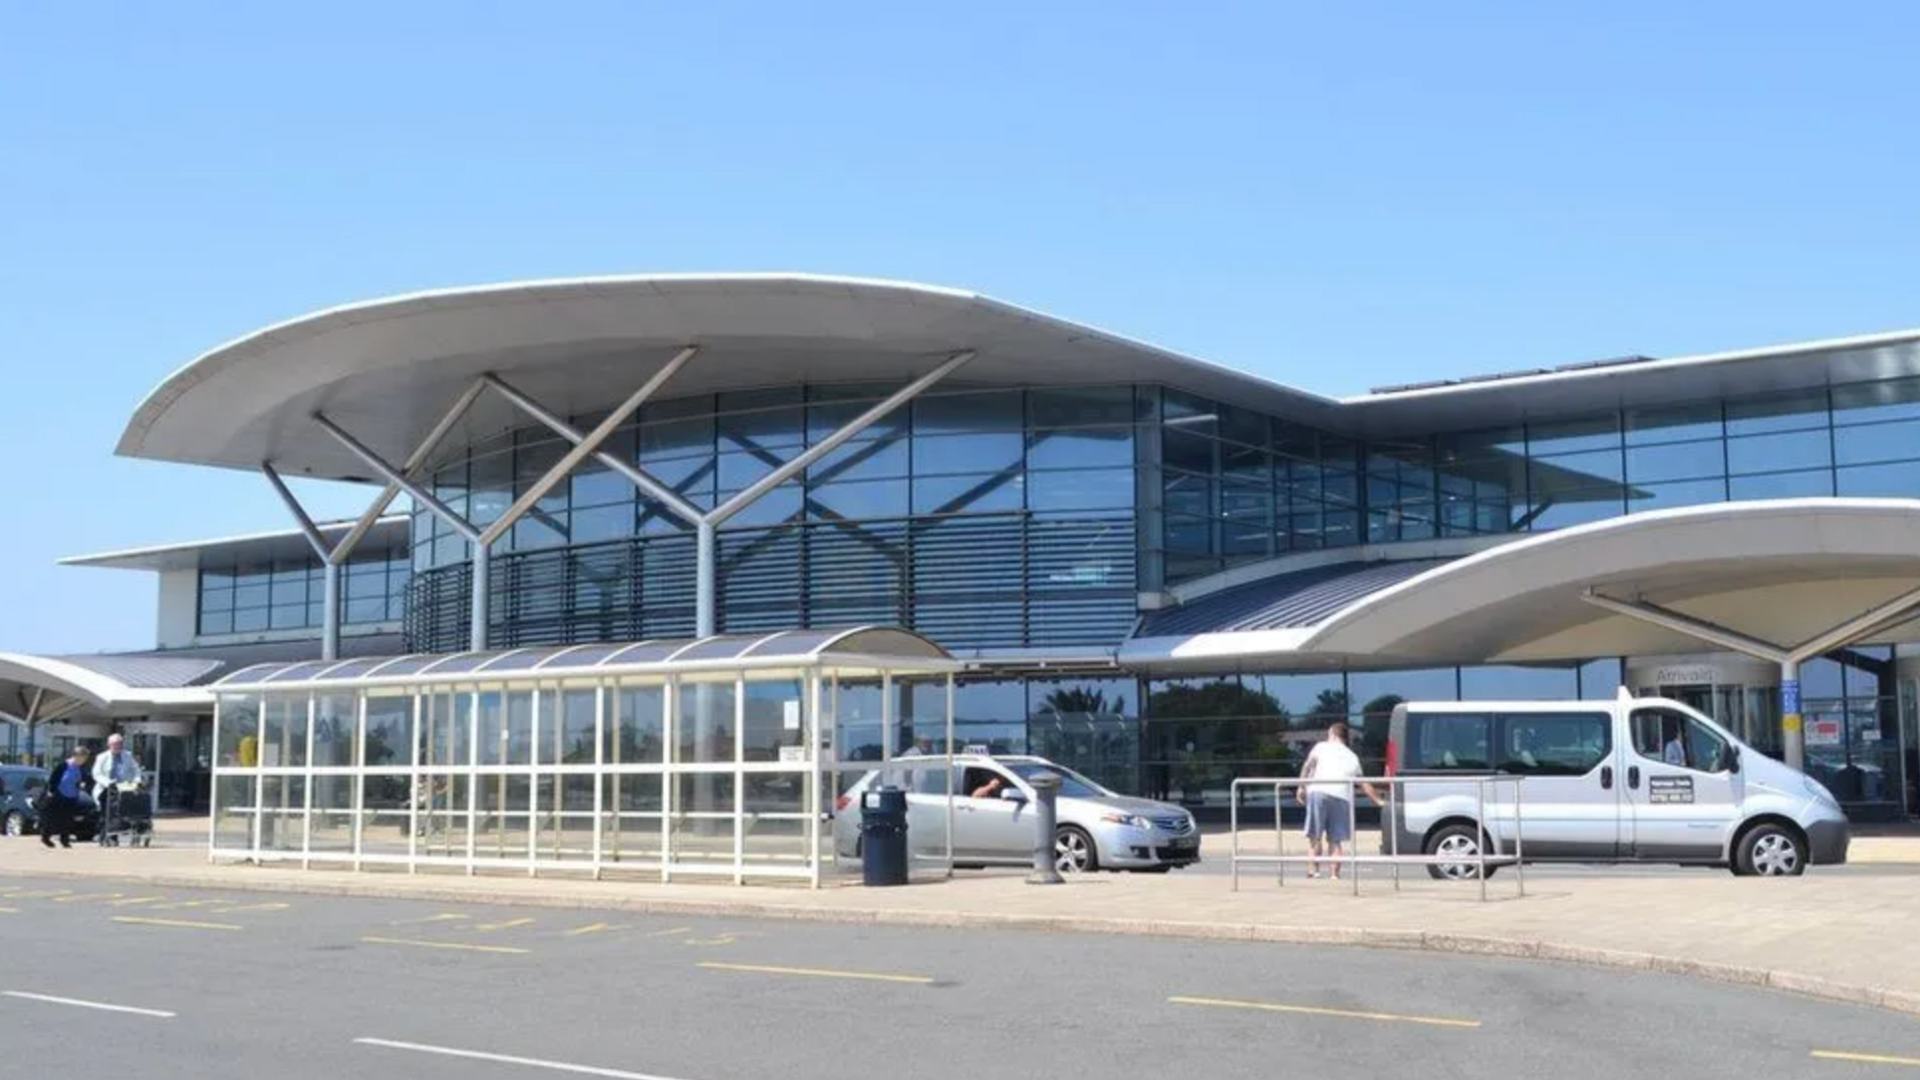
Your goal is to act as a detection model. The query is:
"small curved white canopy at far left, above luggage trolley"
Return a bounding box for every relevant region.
[0,653,223,724]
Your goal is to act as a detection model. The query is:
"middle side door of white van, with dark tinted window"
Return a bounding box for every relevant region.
[1488,705,1622,859]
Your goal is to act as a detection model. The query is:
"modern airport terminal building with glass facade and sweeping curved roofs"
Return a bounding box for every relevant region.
[0,275,1920,819]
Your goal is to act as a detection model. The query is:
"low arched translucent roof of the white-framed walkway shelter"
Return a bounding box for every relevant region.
[215,626,962,692]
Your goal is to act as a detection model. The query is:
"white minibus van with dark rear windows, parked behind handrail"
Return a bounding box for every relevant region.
[1380,688,1849,878]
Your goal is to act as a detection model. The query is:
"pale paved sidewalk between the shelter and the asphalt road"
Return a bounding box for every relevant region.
[0,828,1920,1015]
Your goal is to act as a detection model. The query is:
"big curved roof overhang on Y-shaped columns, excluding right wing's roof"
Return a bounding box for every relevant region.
[119,275,1334,479]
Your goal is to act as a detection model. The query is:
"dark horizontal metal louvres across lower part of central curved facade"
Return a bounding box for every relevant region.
[407,513,1135,651]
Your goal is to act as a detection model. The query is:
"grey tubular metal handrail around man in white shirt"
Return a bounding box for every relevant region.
[1227,776,1526,899]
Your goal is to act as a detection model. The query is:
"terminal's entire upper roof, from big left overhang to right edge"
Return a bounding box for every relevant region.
[119,273,1920,479]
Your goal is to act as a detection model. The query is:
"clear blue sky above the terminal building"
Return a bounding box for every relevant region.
[0,0,1920,651]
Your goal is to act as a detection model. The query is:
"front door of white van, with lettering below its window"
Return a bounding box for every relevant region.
[1624,707,1738,863]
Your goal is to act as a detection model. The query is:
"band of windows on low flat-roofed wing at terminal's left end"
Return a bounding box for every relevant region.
[196,550,407,638]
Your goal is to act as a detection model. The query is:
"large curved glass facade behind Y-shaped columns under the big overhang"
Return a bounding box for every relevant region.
[407,384,1139,651]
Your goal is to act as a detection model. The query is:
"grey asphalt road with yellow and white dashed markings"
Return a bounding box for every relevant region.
[0,880,1920,1080]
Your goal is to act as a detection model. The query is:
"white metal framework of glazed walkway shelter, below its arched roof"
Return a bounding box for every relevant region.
[207,650,960,888]
